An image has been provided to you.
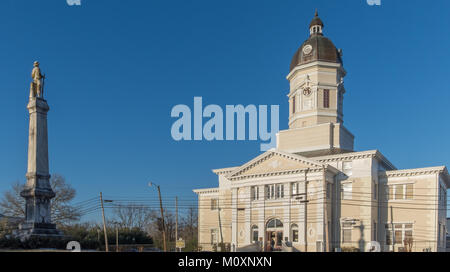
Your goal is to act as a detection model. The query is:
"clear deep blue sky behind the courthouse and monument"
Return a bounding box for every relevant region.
[0,0,450,220]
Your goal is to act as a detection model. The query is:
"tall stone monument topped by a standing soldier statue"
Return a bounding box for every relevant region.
[19,62,62,238]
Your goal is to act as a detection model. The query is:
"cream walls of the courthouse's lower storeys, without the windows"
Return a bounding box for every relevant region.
[199,154,446,252]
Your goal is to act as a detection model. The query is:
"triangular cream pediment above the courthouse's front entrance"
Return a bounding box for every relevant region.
[229,151,324,178]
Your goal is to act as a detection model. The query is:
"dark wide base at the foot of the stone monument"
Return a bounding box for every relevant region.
[14,223,65,241]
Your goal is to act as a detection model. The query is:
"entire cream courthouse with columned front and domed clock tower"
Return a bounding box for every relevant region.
[194,13,450,252]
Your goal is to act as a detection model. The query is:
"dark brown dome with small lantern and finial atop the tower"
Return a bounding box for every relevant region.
[289,10,342,71]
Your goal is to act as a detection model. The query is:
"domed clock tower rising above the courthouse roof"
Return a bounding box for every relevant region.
[277,11,354,156]
